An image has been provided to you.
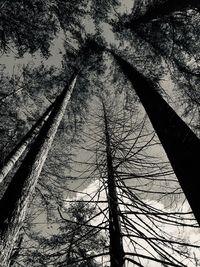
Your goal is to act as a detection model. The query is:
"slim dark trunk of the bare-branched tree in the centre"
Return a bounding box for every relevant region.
[102,101,124,267]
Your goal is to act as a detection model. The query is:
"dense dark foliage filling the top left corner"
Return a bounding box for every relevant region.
[0,0,90,57]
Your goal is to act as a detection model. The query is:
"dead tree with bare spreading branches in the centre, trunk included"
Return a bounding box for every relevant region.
[59,92,198,266]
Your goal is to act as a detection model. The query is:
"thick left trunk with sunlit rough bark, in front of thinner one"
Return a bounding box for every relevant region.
[0,74,77,267]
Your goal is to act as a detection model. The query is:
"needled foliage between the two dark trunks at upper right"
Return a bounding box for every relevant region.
[114,6,199,144]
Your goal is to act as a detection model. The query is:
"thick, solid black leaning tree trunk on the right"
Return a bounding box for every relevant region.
[112,53,200,228]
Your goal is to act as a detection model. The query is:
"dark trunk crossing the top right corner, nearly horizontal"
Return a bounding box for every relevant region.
[129,0,200,25]
